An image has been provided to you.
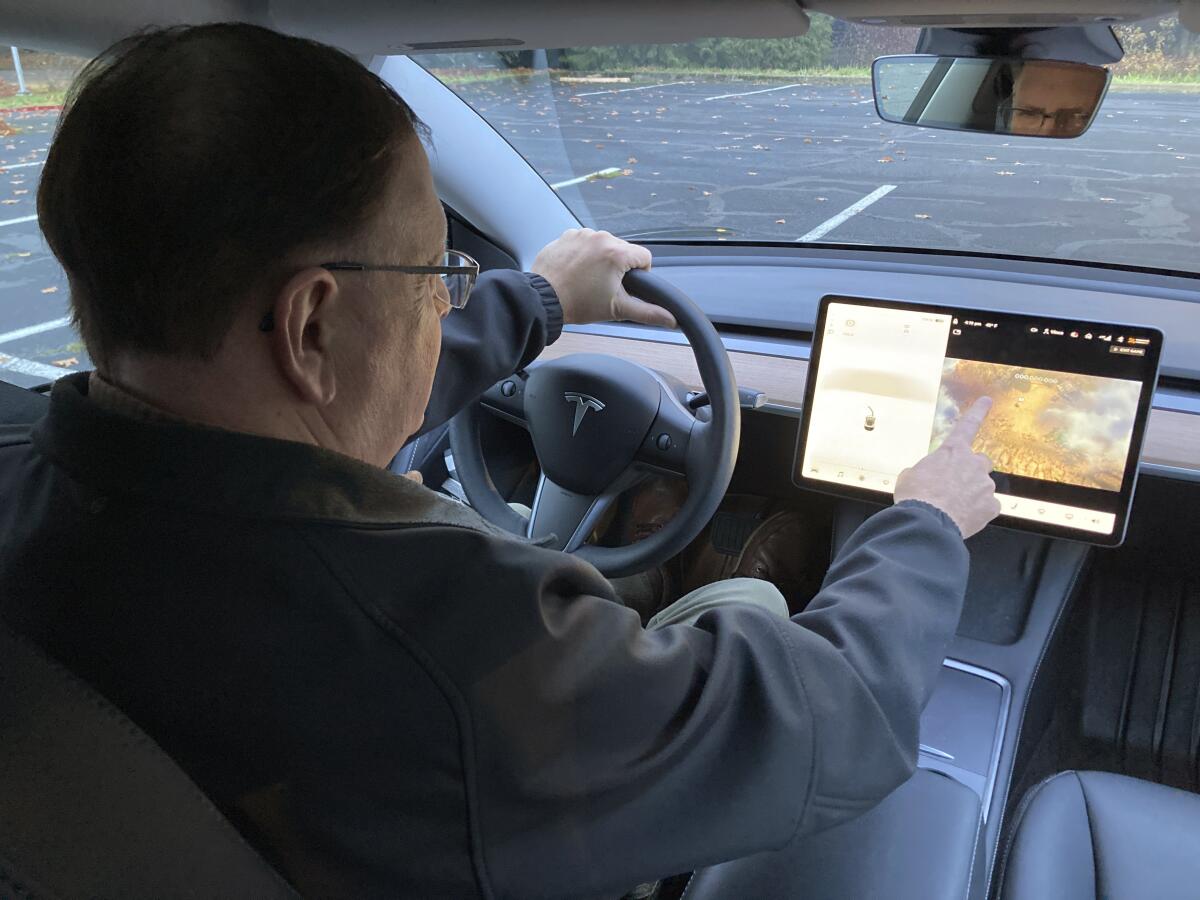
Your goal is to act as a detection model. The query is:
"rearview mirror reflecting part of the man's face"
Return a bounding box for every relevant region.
[871,56,1110,138]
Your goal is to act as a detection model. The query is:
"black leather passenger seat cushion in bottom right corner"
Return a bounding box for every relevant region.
[1002,772,1200,900]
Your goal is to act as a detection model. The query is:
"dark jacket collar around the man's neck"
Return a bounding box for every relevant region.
[32,372,511,536]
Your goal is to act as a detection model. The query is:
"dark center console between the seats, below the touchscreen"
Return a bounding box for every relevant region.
[684,500,1090,900]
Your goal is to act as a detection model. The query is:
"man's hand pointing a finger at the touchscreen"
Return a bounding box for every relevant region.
[894,397,1000,538]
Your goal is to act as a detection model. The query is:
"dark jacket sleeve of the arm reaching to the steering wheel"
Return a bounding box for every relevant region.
[414,269,563,437]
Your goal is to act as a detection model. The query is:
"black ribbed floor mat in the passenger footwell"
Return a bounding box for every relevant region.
[1022,479,1200,791]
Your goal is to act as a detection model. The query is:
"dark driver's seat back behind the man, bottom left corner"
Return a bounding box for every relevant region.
[0,624,299,900]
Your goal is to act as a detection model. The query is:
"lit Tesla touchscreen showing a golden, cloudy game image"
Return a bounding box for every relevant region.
[794,296,1163,546]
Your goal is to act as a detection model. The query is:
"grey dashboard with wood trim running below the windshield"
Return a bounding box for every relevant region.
[544,250,1200,504]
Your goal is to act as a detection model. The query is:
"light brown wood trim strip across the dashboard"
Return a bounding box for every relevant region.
[541,331,1200,470]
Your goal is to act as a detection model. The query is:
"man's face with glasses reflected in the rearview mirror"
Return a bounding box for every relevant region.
[1008,62,1103,138]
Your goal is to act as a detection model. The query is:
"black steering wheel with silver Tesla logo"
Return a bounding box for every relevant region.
[450,269,742,576]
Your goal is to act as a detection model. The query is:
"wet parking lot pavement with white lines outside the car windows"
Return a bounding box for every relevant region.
[0,76,1200,385]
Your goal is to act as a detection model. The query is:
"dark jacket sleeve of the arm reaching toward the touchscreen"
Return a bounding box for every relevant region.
[417,502,967,898]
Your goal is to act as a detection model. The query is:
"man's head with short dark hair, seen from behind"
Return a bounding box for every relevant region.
[38,24,449,462]
